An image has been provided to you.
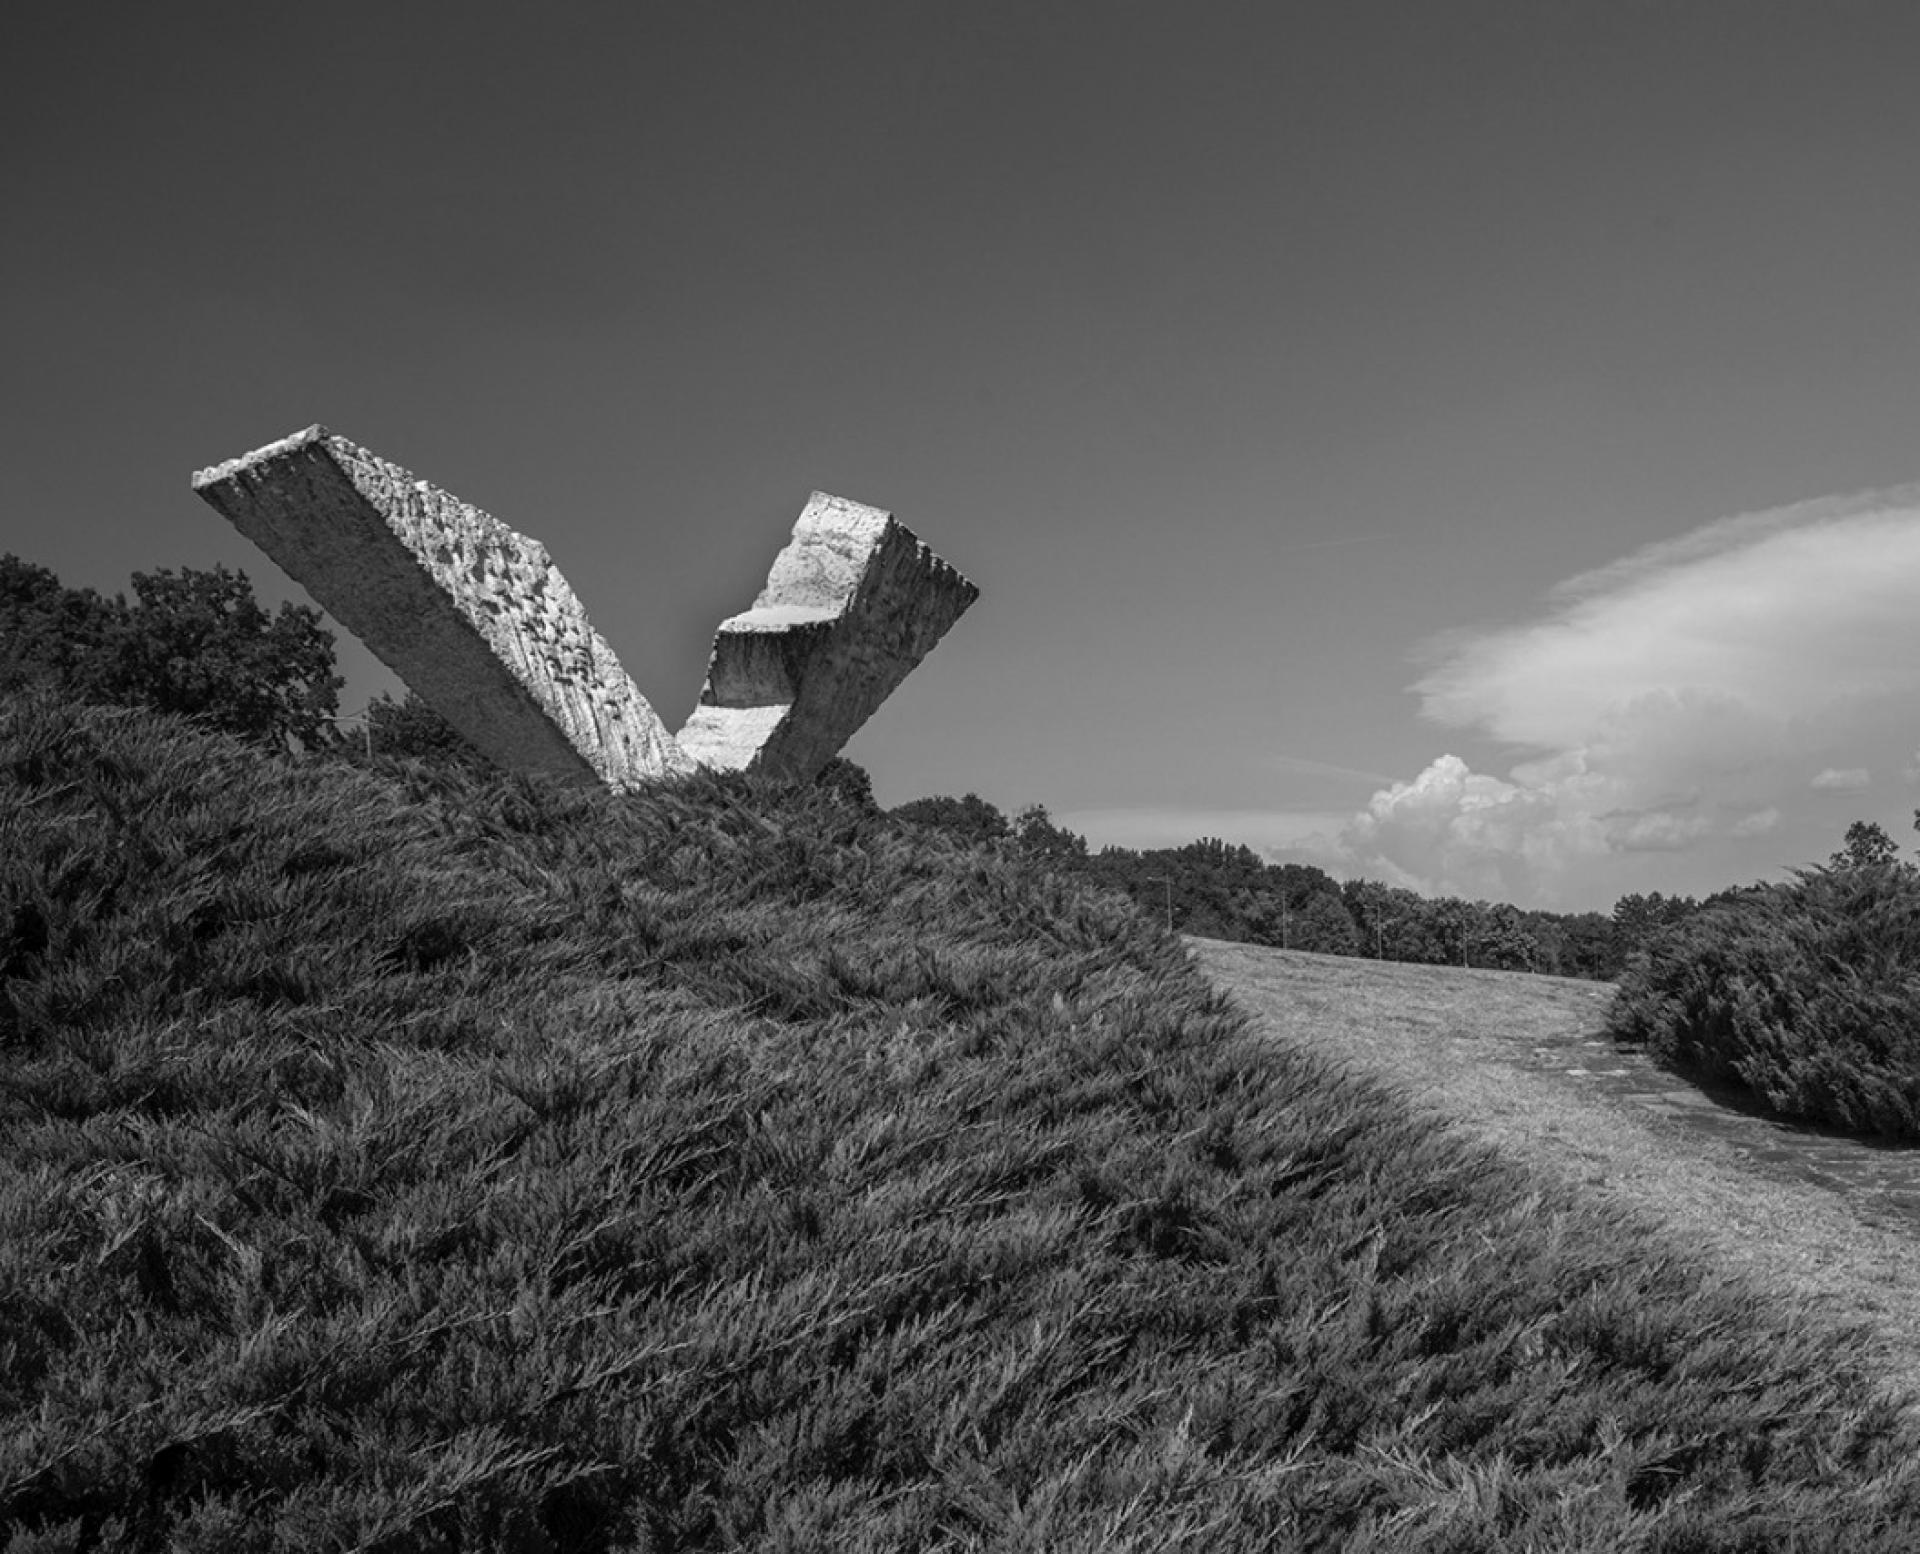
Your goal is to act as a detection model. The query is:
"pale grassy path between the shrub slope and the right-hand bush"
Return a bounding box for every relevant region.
[1187,939,1920,1396]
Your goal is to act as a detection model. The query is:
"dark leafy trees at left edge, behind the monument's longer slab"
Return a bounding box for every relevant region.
[0,555,344,749]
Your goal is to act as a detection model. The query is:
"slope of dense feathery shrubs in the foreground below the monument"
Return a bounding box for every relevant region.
[0,709,1920,1550]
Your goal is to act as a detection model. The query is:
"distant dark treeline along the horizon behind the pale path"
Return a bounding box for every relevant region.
[889,793,1718,982]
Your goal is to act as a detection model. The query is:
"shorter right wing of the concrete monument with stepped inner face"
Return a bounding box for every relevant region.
[680,492,979,782]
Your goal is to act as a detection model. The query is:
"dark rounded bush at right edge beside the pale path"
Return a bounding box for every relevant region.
[1607,862,1920,1139]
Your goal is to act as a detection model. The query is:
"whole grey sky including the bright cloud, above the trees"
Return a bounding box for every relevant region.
[0,0,1920,911]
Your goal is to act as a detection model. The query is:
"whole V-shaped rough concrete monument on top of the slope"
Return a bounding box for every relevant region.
[194,426,979,789]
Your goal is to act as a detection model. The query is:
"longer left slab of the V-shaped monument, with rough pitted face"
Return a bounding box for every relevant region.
[194,426,693,789]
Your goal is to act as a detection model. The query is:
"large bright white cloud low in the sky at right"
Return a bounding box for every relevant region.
[1340,488,1920,901]
